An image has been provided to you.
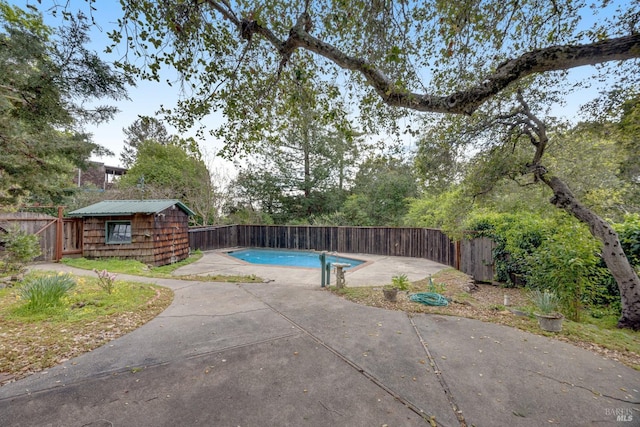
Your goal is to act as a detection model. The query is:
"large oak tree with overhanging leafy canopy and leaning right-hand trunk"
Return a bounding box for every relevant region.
[81,0,640,329]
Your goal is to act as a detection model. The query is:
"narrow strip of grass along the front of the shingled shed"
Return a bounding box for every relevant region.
[60,251,264,283]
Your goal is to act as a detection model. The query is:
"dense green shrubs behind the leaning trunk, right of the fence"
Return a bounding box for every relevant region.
[469,212,624,320]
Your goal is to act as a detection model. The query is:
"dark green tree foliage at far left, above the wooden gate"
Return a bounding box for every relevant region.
[0,1,129,204]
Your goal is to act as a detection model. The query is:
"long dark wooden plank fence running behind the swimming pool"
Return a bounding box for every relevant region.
[189,225,495,282]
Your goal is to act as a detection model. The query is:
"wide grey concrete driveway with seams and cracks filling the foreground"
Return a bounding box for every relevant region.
[0,256,640,427]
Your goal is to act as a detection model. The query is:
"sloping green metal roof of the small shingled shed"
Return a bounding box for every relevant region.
[68,199,195,217]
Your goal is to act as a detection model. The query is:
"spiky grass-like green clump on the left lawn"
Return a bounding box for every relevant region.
[18,274,76,312]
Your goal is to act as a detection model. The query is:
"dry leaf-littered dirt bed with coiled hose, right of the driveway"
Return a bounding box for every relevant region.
[330,269,640,370]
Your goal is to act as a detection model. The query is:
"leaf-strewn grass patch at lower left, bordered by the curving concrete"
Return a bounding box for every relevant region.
[0,272,173,379]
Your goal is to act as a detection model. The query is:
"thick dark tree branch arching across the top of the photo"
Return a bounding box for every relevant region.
[207,0,640,115]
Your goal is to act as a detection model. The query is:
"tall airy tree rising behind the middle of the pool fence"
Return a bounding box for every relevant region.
[228,74,363,223]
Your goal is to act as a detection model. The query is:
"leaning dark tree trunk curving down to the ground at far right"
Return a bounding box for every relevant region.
[538,174,640,331]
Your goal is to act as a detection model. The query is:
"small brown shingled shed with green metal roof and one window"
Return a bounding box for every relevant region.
[68,200,194,266]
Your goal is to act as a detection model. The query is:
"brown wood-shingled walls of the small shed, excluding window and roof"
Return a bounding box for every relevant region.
[83,208,189,266]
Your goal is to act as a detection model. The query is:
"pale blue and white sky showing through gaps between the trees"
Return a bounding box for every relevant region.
[9,0,632,175]
